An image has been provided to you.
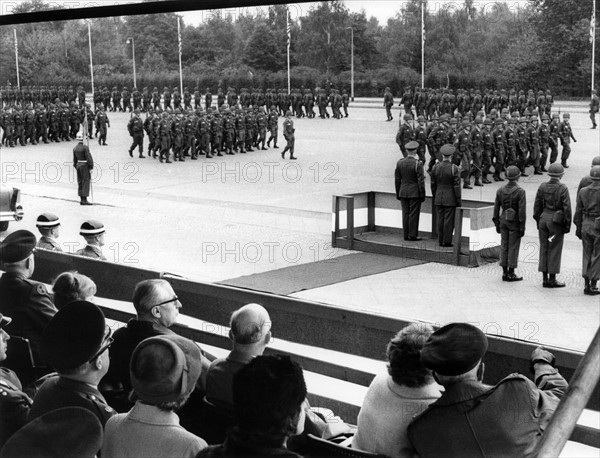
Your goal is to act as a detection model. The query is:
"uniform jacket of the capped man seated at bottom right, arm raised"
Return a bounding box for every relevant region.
[408,364,568,458]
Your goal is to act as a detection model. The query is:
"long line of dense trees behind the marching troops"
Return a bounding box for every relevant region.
[0,0,600,97]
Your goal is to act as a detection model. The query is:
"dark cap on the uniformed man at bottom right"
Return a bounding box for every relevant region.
[421,323,488,375]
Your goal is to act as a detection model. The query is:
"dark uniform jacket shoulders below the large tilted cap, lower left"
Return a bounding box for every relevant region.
[29,375,116,426]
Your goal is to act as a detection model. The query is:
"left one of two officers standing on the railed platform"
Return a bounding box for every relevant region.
[395,140,425,242]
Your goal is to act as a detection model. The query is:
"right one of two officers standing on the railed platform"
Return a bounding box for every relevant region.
[431,144,461,247]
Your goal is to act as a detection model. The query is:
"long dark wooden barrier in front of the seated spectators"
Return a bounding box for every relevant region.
[33,249,600,447]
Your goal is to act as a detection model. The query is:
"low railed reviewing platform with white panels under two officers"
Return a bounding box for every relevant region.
[331,191,500,267]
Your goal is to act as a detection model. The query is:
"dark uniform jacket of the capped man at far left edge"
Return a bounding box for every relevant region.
[0,272,57,363]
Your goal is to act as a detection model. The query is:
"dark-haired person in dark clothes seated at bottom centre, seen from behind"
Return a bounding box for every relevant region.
[198,356,306,458]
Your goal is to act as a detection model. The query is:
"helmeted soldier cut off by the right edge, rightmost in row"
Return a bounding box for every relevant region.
[574,165,600,296]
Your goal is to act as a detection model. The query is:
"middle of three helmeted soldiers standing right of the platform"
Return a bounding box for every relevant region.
[533,164,571,288]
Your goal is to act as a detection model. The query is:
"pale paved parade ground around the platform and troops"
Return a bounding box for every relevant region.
[0,102,600,350]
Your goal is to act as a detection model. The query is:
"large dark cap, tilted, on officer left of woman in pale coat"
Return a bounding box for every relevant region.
[40,301,106,370]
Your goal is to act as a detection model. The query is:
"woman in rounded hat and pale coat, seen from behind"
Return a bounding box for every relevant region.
[102,335,207,458]
